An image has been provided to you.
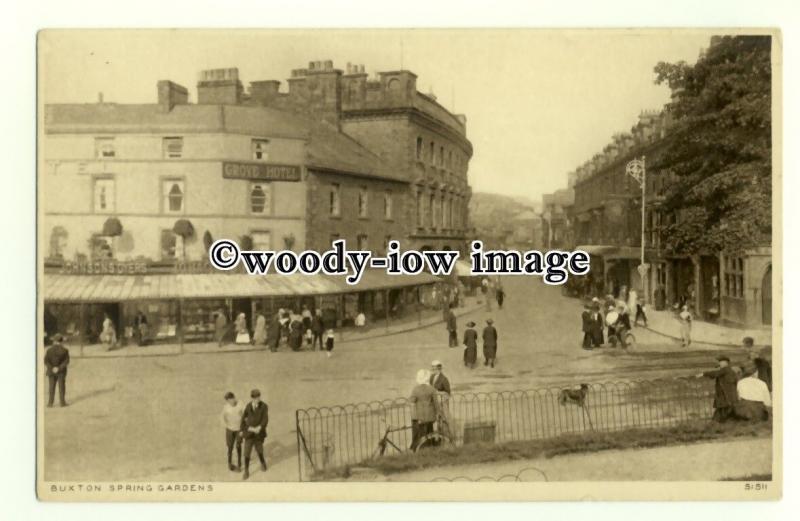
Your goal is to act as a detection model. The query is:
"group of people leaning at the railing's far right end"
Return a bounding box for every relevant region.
[697,337,772,423]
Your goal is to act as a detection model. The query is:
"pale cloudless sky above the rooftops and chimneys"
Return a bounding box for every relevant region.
[39,29,711,201]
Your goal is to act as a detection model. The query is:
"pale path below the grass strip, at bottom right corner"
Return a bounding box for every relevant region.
[378,438,772,481]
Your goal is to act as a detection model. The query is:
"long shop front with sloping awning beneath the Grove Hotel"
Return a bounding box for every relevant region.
[43,270,442,350]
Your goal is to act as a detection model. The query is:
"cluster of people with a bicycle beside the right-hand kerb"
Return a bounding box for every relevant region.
[581,286,647,349]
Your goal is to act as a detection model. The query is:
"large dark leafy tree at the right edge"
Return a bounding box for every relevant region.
[652,36,772,253]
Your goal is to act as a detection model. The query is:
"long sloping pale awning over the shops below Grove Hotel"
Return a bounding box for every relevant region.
[43,270,440,302]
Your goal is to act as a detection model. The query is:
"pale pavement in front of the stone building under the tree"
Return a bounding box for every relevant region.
[646,307,772,347]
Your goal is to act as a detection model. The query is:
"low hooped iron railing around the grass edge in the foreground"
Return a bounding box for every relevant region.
[295,378,714,480]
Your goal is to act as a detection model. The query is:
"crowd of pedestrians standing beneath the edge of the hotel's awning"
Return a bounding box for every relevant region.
[214,306,336,356]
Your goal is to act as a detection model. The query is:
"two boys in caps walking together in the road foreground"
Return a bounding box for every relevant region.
[220,389,269,479]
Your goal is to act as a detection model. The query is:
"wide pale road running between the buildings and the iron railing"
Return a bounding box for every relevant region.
[44,277,744,481]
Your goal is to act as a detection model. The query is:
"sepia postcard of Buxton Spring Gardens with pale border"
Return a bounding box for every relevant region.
[35,28,783,502]
